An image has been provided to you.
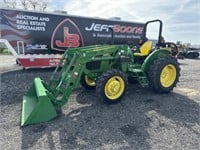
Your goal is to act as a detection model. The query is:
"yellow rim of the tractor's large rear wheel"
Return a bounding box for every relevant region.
[160,64,176,87]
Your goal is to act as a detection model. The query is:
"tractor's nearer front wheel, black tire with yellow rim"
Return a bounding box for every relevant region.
[96,69,127,103]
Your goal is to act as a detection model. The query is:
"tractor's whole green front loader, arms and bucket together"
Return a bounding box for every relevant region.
[21,45,132,126]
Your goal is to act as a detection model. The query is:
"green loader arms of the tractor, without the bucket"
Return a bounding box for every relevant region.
[45,45,130,107]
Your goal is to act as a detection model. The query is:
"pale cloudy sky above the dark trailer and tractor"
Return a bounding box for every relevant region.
[48,0,200,44]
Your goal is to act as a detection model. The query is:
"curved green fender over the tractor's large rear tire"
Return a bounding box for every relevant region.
[141,49,171,72]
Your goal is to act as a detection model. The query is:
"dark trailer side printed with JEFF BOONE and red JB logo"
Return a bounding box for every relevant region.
[0,9,144,54]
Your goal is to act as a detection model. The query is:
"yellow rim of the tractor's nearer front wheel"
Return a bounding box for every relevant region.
[105,76,125,100]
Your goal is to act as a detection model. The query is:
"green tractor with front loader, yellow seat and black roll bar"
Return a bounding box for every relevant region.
[21,20,180,126]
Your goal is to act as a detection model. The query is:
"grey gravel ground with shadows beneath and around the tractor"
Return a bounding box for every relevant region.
[0,55,200,150]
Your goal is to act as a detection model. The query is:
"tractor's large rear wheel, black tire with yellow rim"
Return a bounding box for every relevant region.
[148,56,180,93]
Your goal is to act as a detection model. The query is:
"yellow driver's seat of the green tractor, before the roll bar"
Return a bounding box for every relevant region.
[134,41,153,56]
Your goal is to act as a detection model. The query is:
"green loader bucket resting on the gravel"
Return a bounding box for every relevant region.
[21,78,57,126]
